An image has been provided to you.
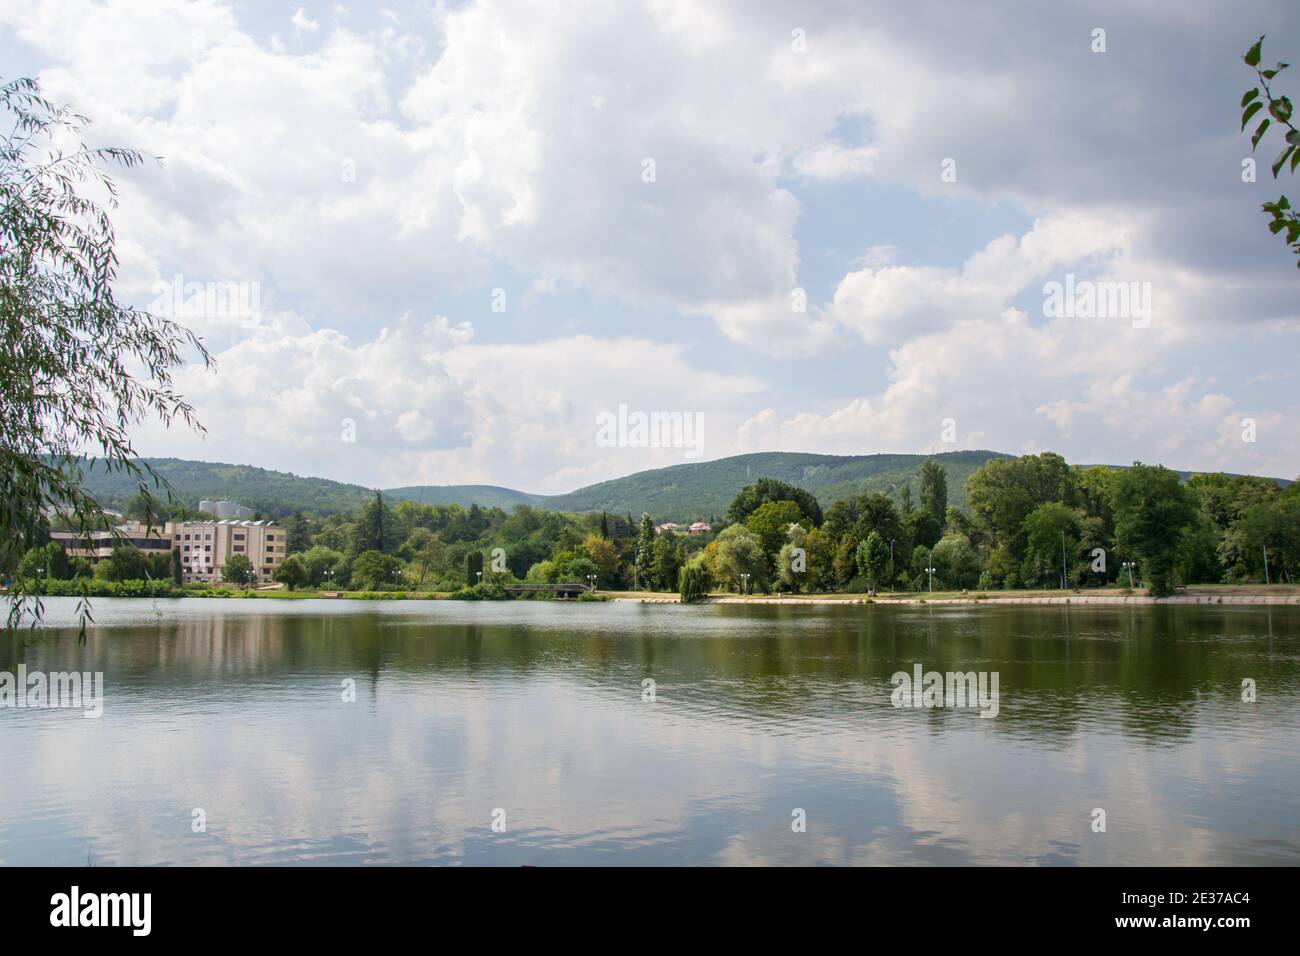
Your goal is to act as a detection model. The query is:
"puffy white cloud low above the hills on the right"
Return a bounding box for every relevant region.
[737,310,1300,477]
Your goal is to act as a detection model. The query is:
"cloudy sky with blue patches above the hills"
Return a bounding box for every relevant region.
[0,0,1300,493]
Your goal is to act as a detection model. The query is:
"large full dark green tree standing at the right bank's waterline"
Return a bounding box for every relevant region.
[1112,462,1195,597]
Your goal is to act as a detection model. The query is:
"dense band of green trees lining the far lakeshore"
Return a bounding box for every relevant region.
[12,453,1300,601]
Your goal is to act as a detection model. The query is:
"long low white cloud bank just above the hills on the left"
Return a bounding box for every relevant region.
[139,313,762,492]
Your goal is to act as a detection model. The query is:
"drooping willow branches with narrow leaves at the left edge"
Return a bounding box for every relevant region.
[0,78,209,639]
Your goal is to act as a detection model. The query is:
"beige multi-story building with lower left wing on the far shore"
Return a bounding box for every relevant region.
[51,520,287,581]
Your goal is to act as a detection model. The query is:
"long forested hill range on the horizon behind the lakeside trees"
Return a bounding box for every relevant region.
[68,451,1286,522]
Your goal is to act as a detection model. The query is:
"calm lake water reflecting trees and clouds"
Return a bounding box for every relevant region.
[0,600,1300,866]
